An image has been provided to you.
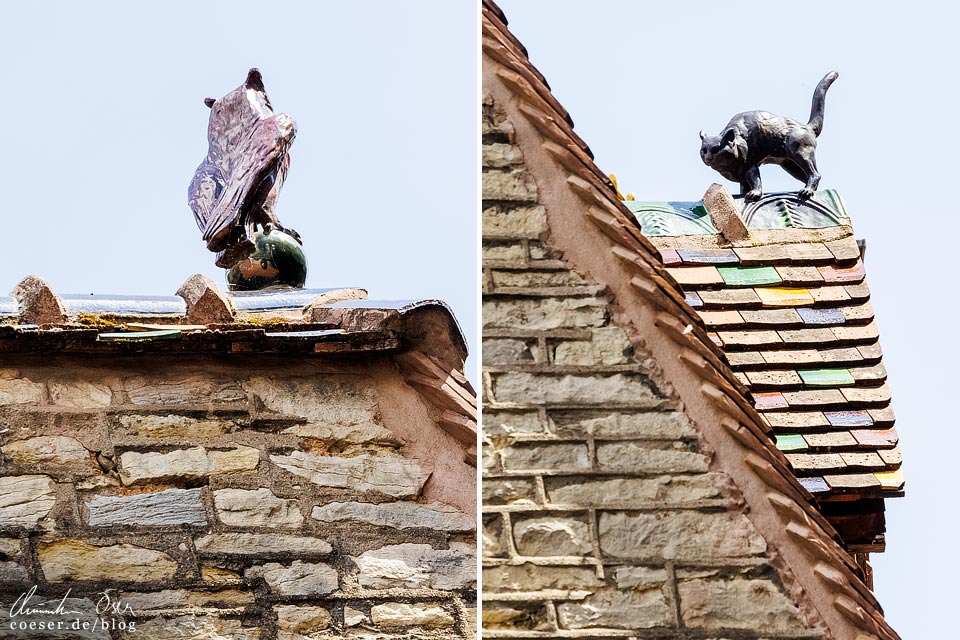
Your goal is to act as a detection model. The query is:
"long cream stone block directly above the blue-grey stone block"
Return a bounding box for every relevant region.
[120,447,260,485]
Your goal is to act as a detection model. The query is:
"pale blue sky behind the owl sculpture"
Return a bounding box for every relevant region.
[0,0,478,376]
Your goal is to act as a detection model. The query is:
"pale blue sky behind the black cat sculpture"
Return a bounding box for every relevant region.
[500,0,960,638]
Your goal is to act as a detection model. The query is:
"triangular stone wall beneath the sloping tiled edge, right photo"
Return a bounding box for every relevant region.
[482,97,823,638]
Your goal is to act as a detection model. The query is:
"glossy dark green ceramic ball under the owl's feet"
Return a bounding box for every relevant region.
[227,229,307,291]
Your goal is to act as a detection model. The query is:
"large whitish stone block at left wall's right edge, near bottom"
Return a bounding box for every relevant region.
[352,542,477,589]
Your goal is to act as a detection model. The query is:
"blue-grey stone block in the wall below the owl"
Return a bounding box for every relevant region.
[86,489,207,527]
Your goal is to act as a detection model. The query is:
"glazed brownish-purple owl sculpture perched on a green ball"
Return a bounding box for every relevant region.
[188,69,300,269]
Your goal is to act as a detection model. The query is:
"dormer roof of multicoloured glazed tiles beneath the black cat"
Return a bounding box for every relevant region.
[624,190,903,499]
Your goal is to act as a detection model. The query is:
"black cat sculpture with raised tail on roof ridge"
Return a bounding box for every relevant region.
[700,71,838,202]
